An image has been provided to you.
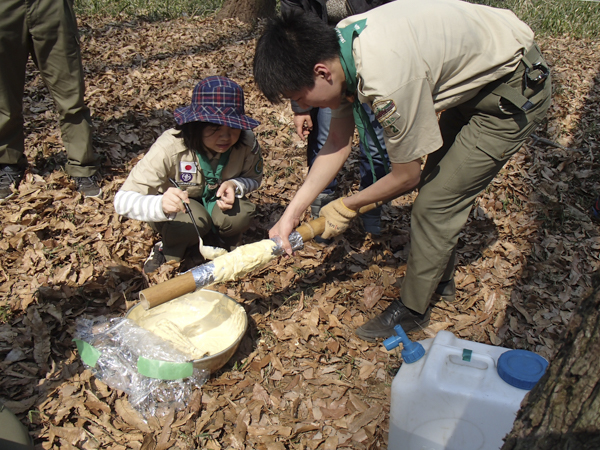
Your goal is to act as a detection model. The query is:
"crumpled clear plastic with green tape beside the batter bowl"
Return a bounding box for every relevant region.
[74,316,210,418]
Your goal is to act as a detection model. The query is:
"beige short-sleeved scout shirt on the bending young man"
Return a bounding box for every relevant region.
[332,0,533,163]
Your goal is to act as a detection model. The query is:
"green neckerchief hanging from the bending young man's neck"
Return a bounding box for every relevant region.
[335,19,390,183]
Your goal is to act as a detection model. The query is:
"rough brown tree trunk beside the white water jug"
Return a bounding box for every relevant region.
[501,277,600,450]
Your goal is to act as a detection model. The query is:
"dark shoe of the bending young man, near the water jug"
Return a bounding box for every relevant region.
[355,300,431,342]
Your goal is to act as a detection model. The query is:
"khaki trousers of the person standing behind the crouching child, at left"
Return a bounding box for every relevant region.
[0,0,97,177]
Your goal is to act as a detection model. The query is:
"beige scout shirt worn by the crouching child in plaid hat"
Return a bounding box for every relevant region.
[121,129,263,199]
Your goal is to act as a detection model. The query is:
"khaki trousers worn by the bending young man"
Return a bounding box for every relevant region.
[401,44,551,313]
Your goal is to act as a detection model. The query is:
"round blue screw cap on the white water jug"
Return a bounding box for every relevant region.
[498,350,548,390]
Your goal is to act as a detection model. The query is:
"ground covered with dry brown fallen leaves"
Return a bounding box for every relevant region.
[0,17,600,449]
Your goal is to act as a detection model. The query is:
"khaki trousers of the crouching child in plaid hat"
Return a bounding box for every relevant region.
[150,198,256,261]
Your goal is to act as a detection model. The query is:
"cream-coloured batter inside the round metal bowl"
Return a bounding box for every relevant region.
[128,290,247,360]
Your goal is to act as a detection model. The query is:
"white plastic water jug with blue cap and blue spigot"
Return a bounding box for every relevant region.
[384,327,548,450]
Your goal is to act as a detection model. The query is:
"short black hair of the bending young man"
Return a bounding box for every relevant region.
[254,13,340,103]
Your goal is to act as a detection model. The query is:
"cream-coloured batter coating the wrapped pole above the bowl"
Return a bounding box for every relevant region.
[213,239,277,283]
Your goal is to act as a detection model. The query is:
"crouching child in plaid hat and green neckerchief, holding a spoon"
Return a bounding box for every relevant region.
[114,76,263,273]
